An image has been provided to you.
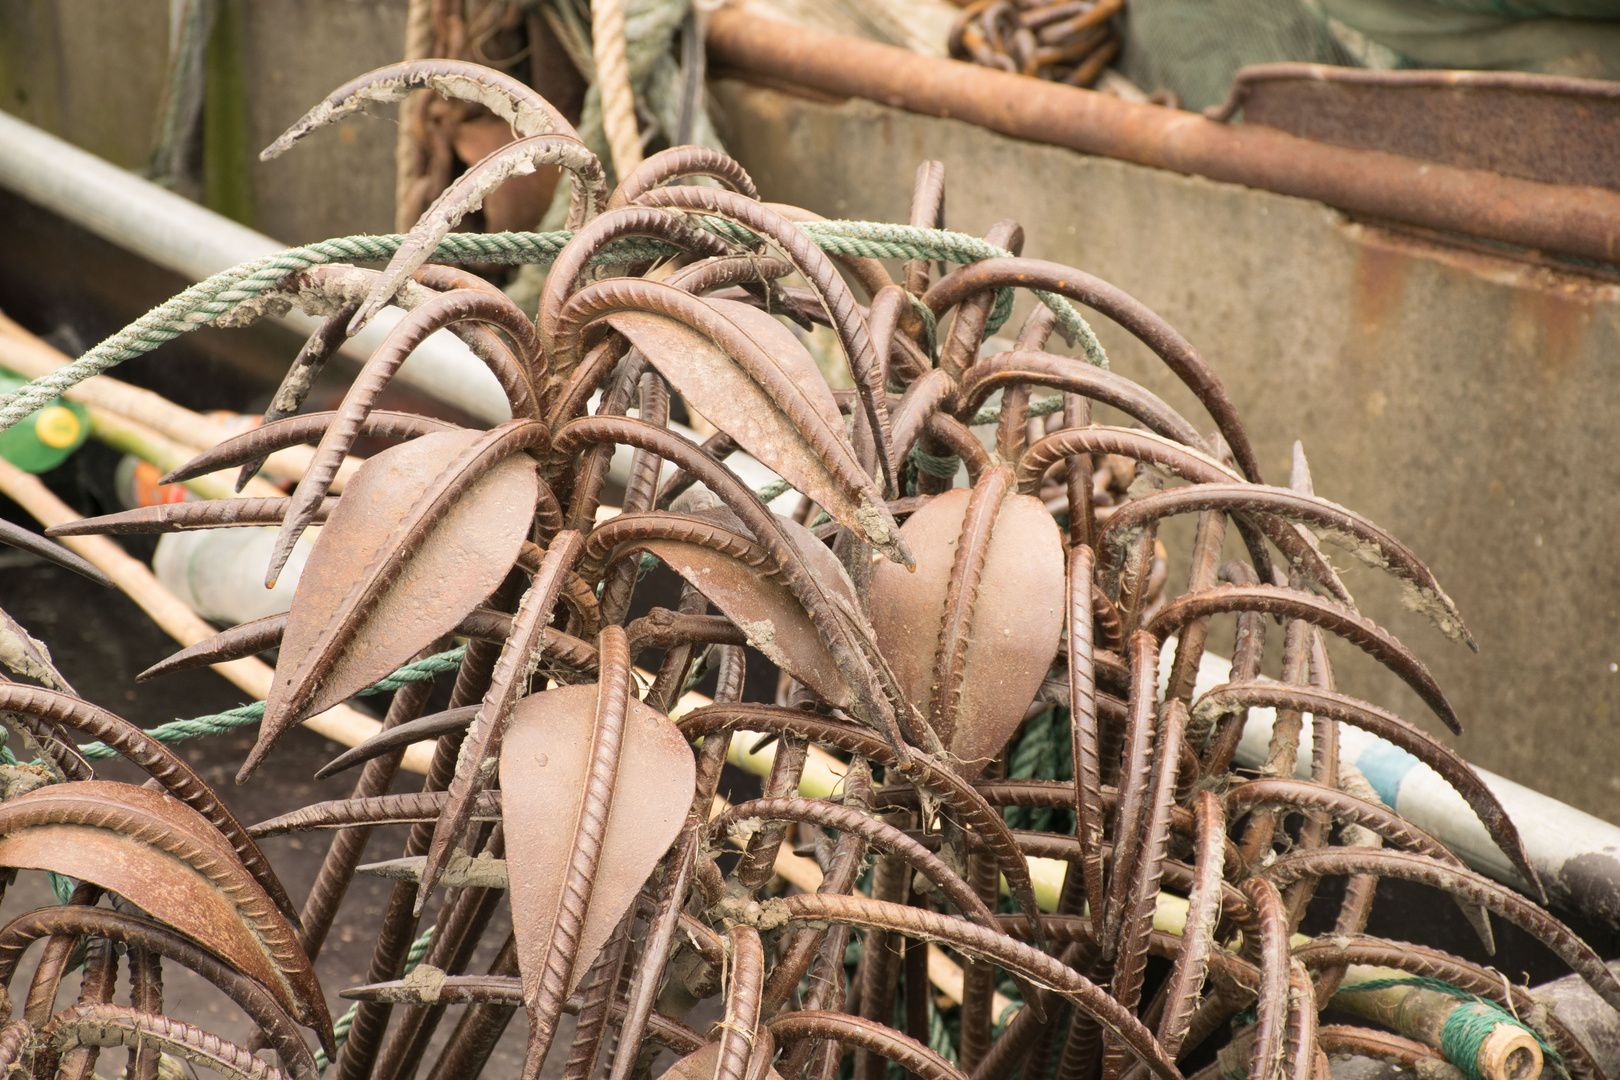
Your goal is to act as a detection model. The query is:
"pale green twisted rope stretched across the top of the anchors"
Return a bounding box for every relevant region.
[0,219,1108,431]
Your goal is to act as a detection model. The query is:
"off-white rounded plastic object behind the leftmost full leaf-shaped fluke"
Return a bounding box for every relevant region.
[152,526,321,627]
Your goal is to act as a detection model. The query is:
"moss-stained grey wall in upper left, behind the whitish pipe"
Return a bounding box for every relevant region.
[0,0,407,244]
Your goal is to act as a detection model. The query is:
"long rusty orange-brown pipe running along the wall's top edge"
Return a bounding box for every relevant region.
[708,8,1620,262]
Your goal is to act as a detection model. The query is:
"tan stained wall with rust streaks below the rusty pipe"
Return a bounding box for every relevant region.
[716,83,1620,821]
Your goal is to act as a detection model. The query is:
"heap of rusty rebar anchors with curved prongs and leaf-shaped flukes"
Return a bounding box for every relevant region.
[0,62,1620,1080]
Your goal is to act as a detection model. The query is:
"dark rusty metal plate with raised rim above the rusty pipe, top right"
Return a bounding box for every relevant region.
[1207,63,1620,191]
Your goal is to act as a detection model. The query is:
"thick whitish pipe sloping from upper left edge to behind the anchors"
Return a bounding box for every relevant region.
[0,112,512,424]
